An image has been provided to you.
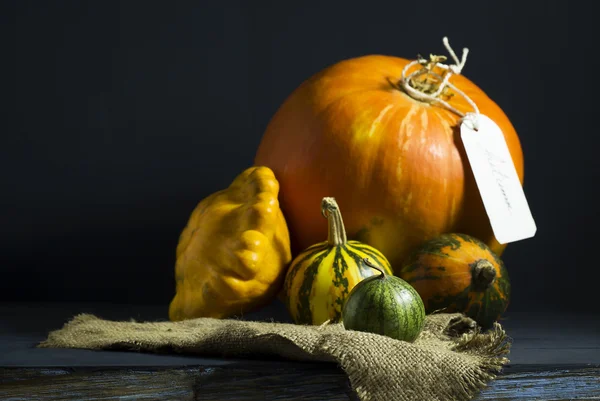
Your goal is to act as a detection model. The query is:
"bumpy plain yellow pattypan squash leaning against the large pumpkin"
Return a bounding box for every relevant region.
[169,166,291,321]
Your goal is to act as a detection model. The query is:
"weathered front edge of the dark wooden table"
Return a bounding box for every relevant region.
[0,362,600,401]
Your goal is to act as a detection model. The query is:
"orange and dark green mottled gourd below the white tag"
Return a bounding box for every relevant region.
[399,233,510,329]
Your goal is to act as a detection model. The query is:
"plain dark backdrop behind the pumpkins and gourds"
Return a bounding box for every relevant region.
[0,0,600,311]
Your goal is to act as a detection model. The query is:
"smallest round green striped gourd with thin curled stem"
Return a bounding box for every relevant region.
[342,260,425,342]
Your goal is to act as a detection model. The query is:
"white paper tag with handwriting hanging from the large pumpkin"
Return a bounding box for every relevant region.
[460,114,537,244]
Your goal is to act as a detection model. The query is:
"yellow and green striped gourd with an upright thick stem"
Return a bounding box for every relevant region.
[283,197,392,325]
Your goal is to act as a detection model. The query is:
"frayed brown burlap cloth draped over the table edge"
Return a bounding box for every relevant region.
[38,314,510,401]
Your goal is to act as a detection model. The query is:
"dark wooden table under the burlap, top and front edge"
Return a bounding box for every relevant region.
[0,304,600,401]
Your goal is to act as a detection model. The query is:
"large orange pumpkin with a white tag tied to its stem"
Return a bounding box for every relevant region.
[255,49,523,269]
